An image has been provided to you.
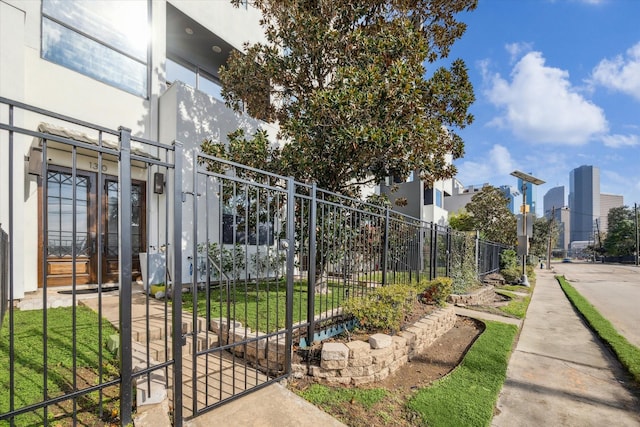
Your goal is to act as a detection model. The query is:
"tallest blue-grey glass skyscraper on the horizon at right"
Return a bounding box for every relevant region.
[569,165,600,242]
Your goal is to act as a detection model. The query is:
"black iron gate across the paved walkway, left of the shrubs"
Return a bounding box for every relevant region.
[183,150,295,417]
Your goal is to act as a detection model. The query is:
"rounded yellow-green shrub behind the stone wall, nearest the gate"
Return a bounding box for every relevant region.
[342,284,416,333]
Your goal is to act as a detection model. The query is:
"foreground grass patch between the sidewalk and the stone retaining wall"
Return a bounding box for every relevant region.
[407,321,518,426]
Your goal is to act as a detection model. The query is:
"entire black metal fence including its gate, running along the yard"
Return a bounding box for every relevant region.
[0,98,510,426]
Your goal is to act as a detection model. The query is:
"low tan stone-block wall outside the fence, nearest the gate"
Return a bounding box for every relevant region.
[292,306,456,385]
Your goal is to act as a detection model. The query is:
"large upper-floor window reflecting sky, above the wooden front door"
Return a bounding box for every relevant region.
[42,0,149,98]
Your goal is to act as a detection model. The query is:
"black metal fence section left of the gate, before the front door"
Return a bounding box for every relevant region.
[0,98,183,426]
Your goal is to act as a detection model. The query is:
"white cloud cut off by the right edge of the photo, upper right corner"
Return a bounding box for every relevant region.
[591,42,640,100]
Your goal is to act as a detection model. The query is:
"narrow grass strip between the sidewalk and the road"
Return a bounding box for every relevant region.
[556,276,640,384]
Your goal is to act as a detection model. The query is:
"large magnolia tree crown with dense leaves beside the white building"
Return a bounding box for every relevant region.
[212,0,477,195]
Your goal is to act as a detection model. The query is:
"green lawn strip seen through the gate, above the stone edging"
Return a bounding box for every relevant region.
[182,281,350,332]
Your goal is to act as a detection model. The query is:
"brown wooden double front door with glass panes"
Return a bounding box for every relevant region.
[38,167,146,287]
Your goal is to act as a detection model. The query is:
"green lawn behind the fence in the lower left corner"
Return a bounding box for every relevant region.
[0,306,119,426]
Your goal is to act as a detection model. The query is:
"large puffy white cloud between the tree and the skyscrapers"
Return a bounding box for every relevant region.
[486,52,608,145]
